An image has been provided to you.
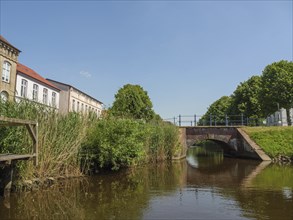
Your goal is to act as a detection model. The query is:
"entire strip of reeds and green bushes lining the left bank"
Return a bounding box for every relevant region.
[0,101,179,187]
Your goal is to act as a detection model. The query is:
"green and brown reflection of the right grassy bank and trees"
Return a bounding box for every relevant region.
[235,164,293,220]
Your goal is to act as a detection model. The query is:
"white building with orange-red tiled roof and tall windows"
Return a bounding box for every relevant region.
[15,63,60,109]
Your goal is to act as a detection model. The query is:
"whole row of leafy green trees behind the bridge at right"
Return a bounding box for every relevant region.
[199,60,293,125]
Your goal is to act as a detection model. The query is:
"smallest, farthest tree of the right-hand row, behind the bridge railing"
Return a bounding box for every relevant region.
[199,96,231,125]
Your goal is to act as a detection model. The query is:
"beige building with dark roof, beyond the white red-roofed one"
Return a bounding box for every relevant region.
[47,79,103,117]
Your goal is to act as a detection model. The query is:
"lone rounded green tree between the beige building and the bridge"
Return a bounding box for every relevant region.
[110,84,155,121]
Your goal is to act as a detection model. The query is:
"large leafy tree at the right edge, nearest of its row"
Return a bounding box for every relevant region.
[260,60,293,125]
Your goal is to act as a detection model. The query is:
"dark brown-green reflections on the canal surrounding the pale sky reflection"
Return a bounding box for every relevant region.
[0,159,293,219]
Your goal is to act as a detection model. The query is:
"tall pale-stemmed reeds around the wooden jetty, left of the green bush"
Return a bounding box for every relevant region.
[0,101,93,179]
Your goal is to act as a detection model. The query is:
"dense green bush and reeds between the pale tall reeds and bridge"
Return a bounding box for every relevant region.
[83,117,179,170]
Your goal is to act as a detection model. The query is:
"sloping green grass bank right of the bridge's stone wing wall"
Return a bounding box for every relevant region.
[242,127,293,158]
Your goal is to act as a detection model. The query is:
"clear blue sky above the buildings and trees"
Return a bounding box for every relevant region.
[0,0,293,118]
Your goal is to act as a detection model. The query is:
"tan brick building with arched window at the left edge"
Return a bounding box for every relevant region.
[0,35,20,101]
